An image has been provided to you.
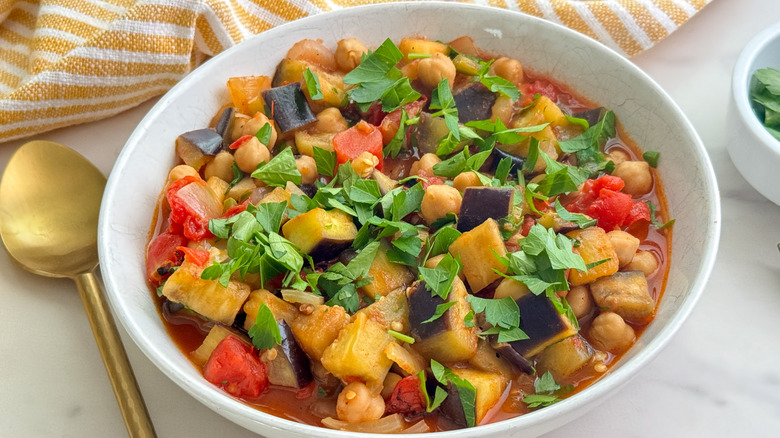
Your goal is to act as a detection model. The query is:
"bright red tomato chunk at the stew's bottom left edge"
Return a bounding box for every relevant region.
[203,335,268,400]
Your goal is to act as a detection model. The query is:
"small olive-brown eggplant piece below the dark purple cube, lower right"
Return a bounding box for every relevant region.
[536,335,595,382]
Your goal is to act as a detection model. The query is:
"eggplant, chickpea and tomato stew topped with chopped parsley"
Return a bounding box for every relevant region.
[146,37,673,433]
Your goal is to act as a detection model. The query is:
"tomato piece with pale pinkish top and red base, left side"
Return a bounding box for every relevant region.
[166,176,222,241]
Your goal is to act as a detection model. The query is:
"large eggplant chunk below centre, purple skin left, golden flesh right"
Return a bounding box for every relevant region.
[409,278,478,363]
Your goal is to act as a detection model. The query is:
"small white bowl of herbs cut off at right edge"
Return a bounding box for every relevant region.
[726,23,780,205]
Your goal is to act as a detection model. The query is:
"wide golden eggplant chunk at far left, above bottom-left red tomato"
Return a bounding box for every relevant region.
[162,260,249,326]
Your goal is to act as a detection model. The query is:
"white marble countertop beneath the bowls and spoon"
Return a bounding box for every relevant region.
[0,0,780,438]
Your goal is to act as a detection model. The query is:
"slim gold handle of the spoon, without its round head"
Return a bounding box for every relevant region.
[74,272,157,438]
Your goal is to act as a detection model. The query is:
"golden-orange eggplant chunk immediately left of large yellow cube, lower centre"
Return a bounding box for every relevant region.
[290,304,349,361]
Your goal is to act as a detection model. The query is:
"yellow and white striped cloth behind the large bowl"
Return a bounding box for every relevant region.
[0,0,711,142]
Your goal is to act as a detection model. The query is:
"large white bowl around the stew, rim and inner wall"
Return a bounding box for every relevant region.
[99,2,720,438]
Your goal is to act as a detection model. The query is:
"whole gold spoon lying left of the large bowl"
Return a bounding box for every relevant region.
[0,140,156,438]
